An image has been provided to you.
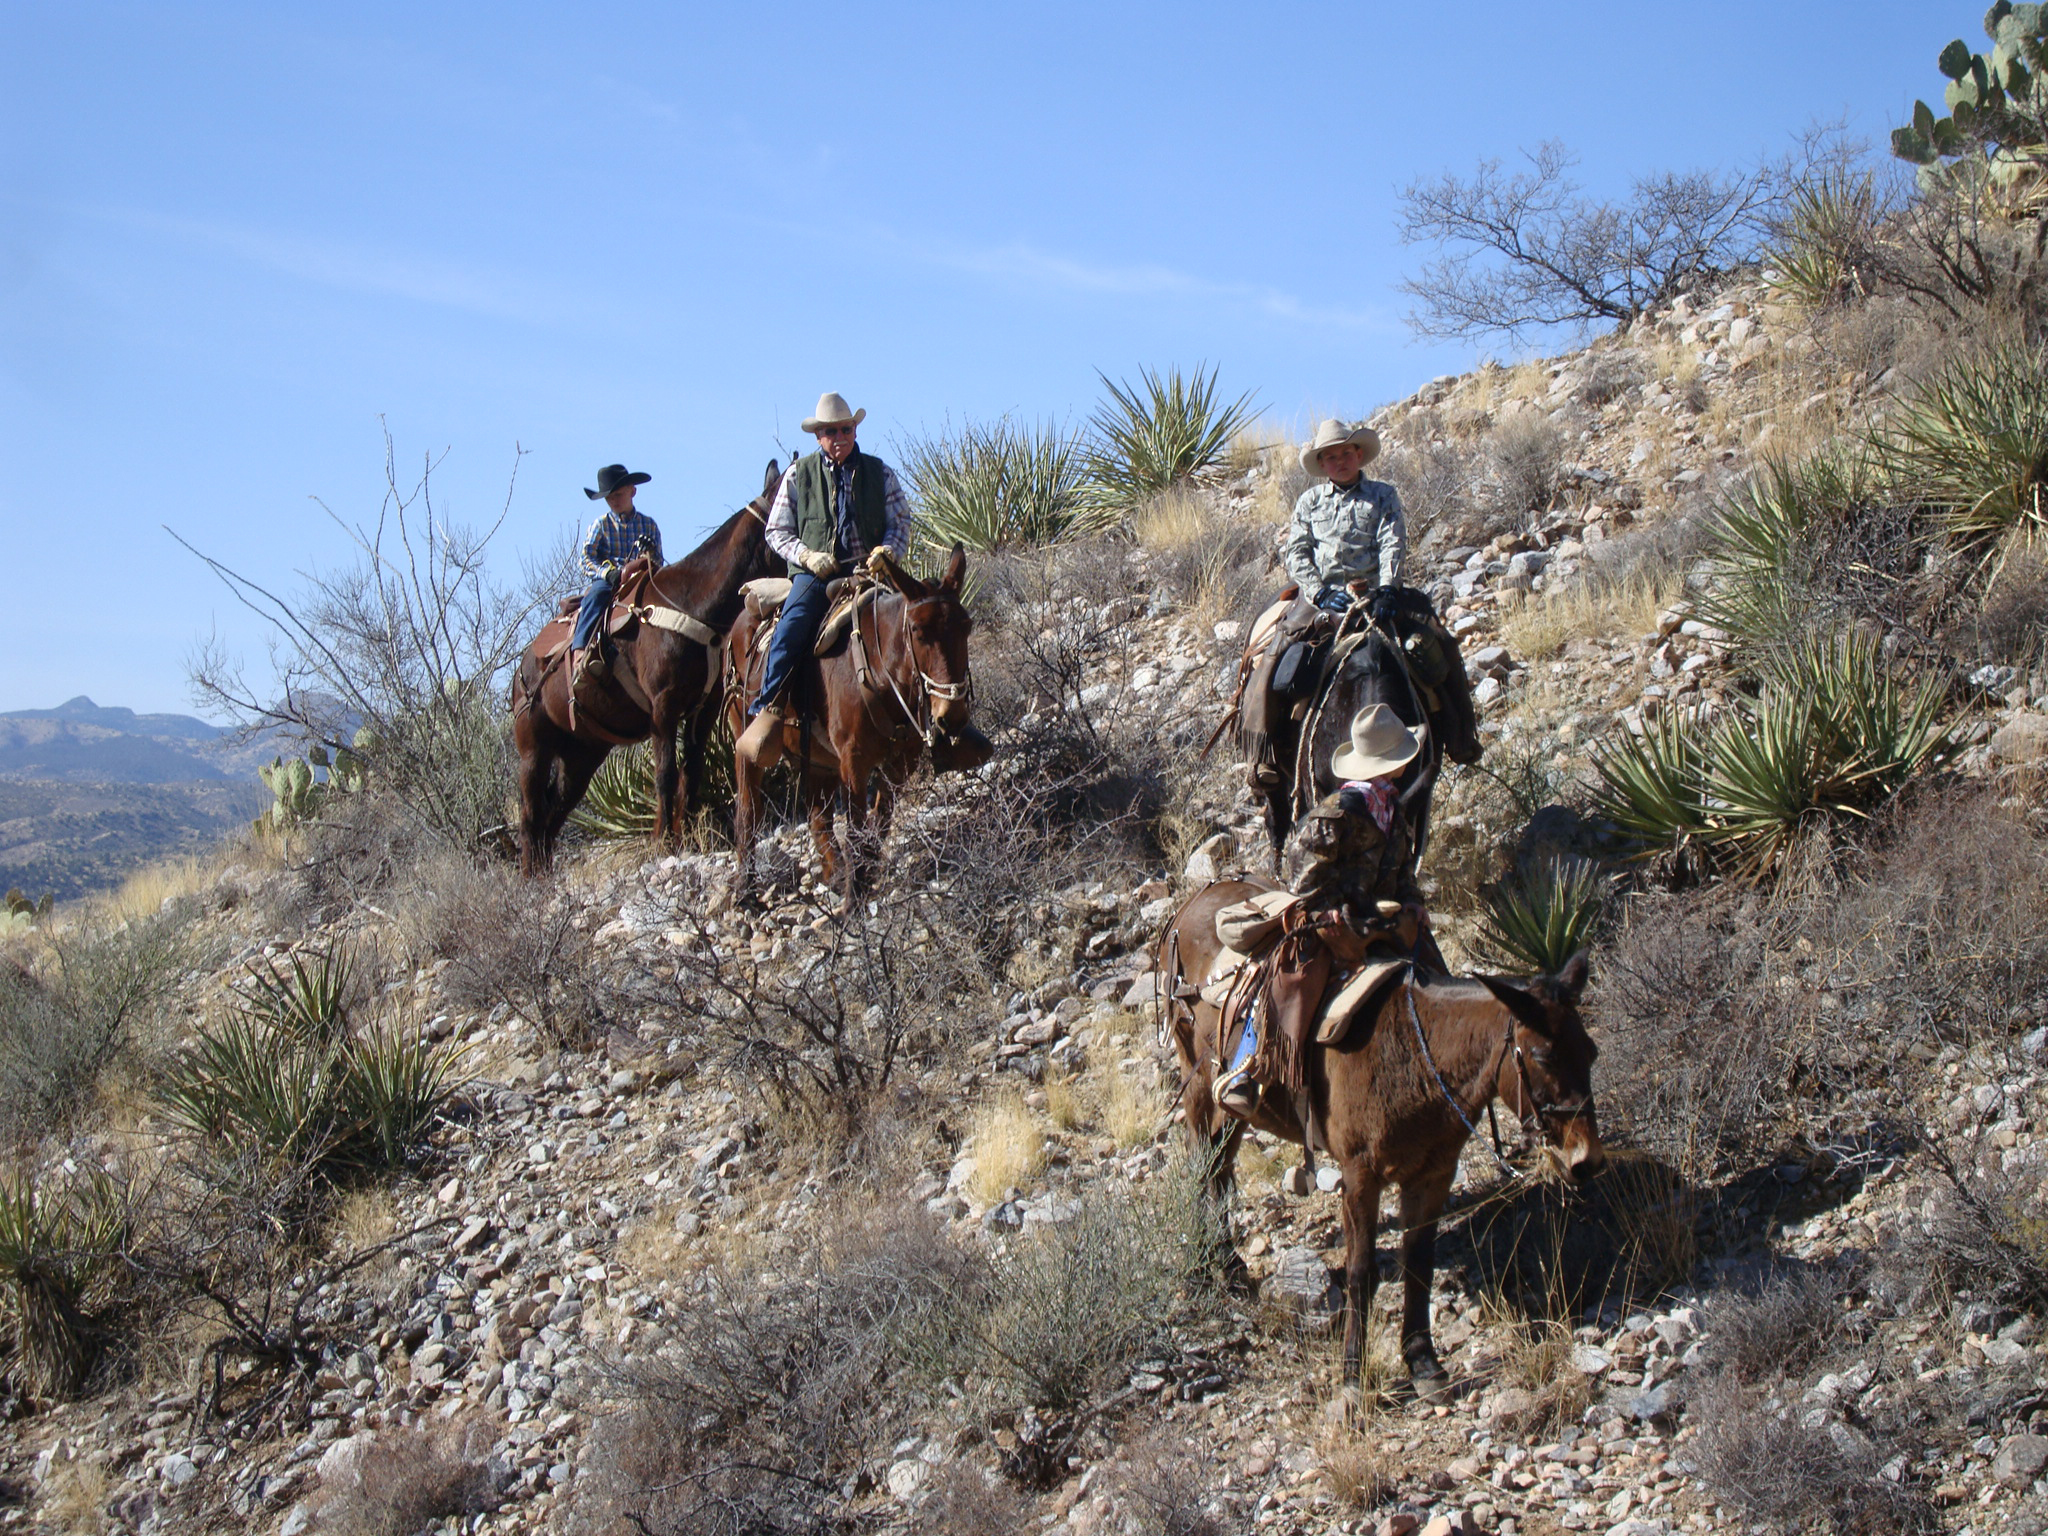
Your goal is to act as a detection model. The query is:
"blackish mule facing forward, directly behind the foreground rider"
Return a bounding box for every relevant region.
[1237,588,1483,872]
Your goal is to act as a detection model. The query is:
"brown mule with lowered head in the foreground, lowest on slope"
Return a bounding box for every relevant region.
[1157,881,1606,1393]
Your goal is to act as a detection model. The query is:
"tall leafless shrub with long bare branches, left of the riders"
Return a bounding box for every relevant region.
[168,432,567,848]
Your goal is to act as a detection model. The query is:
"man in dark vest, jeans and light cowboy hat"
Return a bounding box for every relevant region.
[737,393,909,762]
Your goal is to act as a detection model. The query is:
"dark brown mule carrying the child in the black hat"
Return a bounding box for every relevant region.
[512,459,784,874]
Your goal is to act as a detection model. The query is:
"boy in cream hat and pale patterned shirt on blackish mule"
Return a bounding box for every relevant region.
[1282,422,1407,612]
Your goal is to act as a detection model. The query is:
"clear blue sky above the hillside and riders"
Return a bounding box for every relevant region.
[0,0,1949,711]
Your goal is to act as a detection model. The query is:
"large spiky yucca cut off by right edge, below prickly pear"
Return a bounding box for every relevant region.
[1880,344,2048,559]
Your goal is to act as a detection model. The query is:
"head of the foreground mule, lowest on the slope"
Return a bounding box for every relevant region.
[1481,950,1608,1184]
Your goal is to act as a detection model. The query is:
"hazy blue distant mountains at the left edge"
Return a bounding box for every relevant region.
[0,694,283,901]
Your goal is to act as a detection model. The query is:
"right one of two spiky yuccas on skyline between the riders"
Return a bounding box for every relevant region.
[1087,367,1255,514]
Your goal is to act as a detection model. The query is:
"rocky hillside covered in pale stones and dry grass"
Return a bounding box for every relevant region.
[0,276,2048,1536]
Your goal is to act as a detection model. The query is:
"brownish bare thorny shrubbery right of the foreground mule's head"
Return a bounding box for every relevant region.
[1589,788,2048,1178]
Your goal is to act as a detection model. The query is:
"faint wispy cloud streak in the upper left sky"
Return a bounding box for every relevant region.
[88,209,592,324]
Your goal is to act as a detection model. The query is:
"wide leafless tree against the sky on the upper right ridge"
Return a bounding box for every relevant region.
[1399,141,1784,340]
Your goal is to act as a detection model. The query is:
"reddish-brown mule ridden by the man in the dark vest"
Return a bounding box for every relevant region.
[725,545,973,905]
